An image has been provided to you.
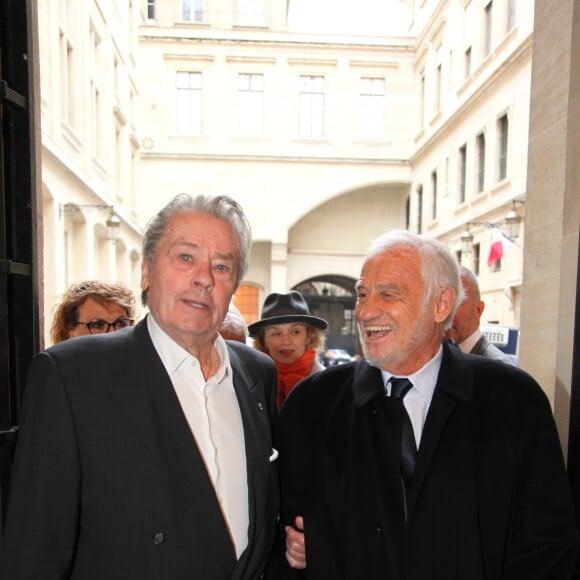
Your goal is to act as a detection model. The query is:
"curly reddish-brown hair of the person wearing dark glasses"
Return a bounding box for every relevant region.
[50,280,136,344]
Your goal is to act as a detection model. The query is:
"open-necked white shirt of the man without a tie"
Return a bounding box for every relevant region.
[147,314,249,558]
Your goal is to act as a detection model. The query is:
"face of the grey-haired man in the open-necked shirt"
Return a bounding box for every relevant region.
[141,212,240,353]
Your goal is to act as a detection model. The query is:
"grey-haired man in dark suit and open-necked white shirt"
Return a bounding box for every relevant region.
[0,194,279,580]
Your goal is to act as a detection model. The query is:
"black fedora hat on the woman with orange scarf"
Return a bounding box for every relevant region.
[248,290,328,336]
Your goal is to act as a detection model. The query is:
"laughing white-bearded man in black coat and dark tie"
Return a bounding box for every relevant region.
[268,230,578,580]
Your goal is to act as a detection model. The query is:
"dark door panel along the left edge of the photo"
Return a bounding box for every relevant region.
[0,0,41,540]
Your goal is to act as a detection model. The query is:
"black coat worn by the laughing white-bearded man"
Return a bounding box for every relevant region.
[270,345,576,580]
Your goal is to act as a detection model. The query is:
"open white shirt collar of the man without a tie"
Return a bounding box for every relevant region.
[147,314,231,382]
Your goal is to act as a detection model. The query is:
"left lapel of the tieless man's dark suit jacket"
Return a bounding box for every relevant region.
[112,320,235,573]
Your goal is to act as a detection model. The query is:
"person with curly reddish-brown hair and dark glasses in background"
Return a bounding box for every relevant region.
[50,280,135,344]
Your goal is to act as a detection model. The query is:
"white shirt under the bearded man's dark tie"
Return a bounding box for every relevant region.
[381,346,443,448]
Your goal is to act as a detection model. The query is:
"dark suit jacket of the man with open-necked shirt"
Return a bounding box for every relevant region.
[0,321,279,580]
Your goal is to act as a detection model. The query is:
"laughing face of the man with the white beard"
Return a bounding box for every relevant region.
[356,247,455,375]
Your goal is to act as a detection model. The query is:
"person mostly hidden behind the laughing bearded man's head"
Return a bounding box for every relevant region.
[445,266,517,366]
